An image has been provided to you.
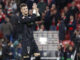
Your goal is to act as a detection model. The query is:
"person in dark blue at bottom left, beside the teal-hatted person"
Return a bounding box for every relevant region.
[3,42,14,60]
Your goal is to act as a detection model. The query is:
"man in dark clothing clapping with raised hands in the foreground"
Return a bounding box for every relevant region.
[18,3,40,60]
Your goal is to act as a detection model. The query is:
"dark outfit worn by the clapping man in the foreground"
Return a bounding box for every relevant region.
[18,15,38,56]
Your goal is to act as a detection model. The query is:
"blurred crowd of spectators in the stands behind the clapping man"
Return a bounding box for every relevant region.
[0,0,80,60]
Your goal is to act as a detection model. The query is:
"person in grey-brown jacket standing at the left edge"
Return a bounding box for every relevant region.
[1,17,13,41]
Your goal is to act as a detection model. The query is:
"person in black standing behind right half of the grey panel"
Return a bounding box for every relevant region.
[45,6,60,30]
